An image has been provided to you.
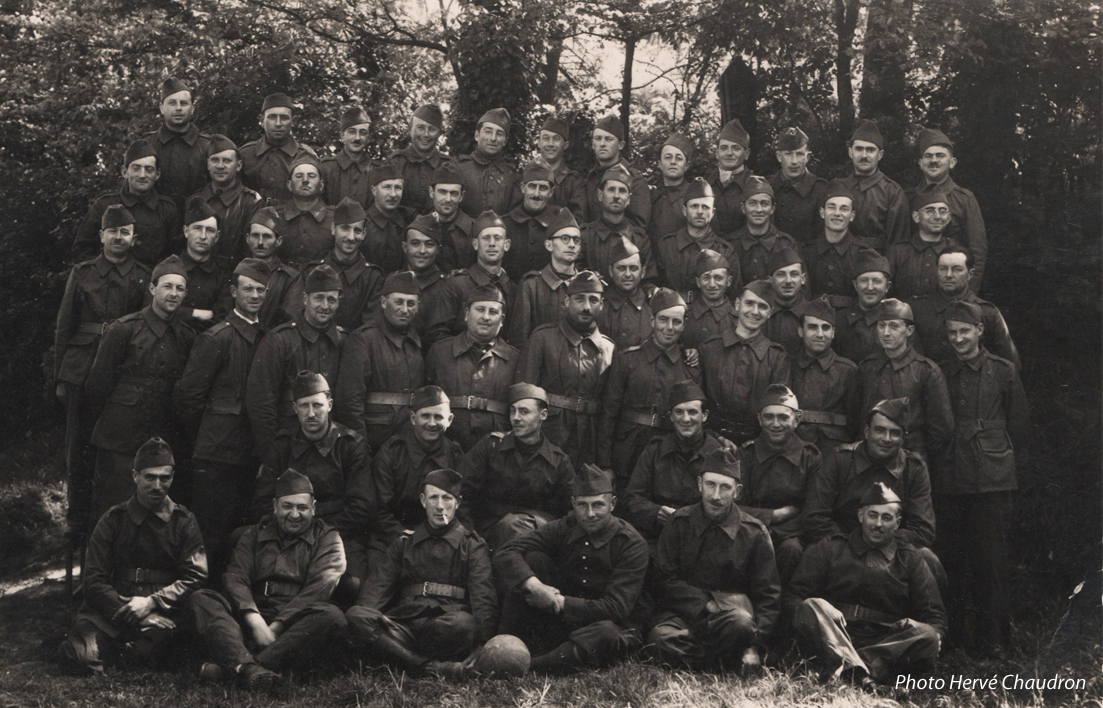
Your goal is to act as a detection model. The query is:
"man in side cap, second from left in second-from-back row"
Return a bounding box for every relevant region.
[189,136,264,269]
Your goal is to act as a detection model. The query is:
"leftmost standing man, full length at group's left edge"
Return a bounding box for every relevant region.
[54,204,150,545]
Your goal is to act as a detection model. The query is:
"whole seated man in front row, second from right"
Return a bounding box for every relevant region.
[647,450,781,672]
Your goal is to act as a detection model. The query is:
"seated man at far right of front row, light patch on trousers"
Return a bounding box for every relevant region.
[784,482,946,688]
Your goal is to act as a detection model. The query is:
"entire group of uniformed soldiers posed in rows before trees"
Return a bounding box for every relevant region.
[54,78,1029,688]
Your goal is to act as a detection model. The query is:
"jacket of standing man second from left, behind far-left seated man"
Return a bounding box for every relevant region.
[85,305,195,454]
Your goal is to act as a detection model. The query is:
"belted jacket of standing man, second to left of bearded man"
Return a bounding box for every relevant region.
[333,318,425,435]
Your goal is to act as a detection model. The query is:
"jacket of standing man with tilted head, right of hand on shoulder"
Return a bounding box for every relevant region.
[698,328,790,426]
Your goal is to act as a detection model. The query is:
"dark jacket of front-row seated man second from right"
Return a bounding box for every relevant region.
[655,502,781,637]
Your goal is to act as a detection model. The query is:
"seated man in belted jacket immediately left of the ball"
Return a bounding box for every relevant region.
[345,469,497,678]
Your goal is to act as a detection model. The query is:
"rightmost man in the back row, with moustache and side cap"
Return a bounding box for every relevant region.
[904,128,988,293]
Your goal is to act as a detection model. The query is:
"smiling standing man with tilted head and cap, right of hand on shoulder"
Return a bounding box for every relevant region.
[698,280,790,443]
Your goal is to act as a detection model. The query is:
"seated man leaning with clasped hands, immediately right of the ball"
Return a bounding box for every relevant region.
[494,464,647,673]
